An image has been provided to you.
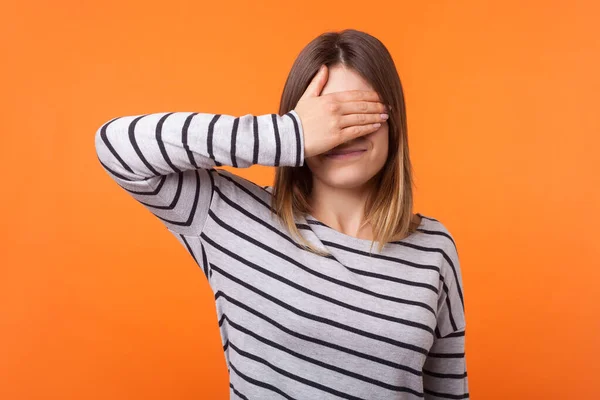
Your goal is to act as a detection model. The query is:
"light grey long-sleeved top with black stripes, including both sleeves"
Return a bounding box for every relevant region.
[95,110,469,400]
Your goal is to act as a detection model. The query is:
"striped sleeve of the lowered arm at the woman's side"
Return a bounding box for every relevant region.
[423,236,469,400]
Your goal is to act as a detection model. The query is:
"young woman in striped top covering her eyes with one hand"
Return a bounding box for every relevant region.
[95,30,469,400]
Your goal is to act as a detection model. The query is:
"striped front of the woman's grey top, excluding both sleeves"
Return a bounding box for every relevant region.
[195,172,448,398]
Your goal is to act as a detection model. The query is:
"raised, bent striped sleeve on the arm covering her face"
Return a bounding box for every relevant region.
[95,110,304,236]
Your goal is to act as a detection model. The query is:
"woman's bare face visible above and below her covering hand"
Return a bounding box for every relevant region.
[306,65,388,189]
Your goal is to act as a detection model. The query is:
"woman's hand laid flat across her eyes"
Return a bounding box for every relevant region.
[294,65,387,158]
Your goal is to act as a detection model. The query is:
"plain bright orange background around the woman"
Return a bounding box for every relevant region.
[0,0,600,400]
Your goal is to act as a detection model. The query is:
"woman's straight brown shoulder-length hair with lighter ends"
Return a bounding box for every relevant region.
[272,29,416,255]
